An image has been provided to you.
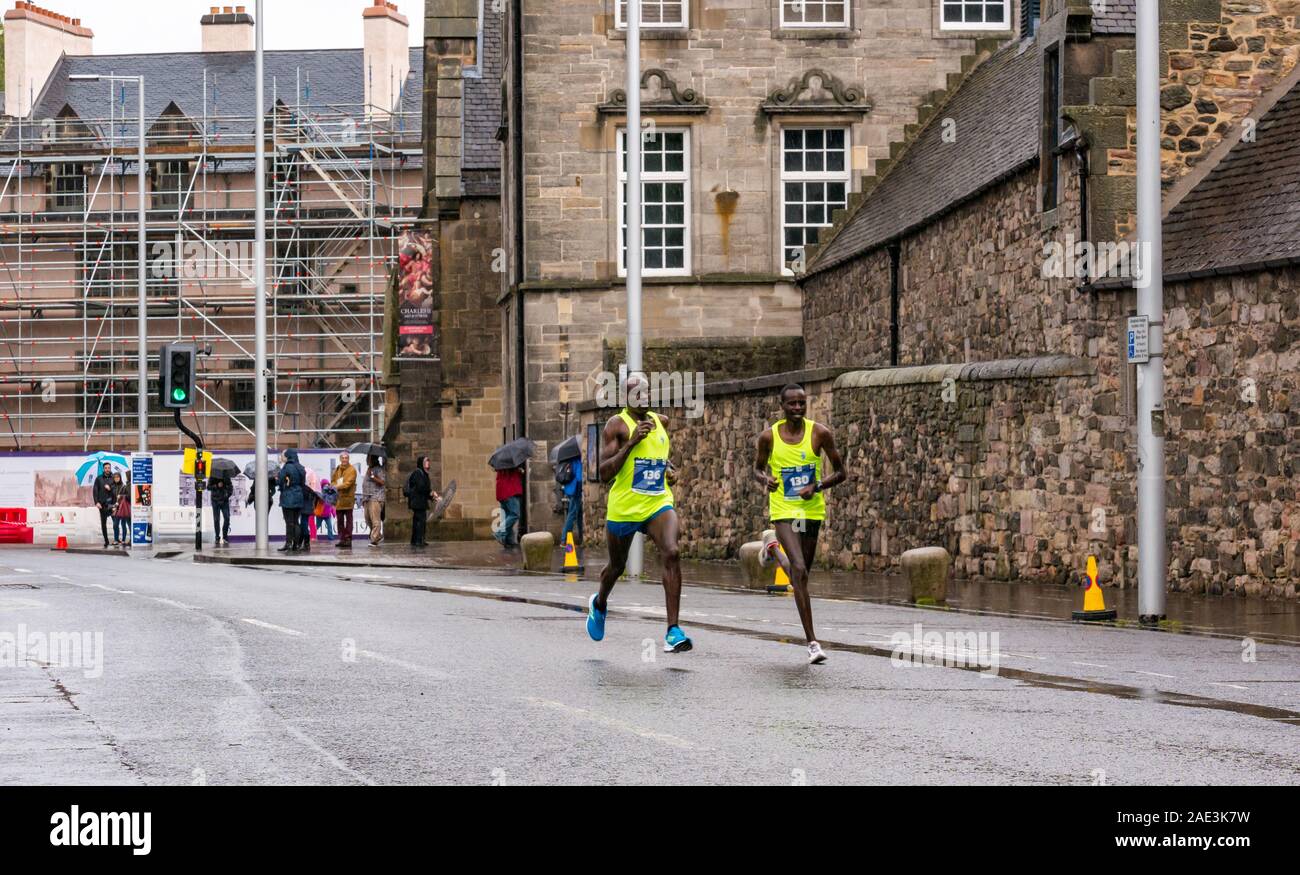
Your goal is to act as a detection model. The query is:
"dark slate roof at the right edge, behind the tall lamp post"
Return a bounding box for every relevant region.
[1165,78,1300,278]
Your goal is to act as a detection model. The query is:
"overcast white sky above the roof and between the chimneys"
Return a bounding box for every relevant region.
[36,0,424,55]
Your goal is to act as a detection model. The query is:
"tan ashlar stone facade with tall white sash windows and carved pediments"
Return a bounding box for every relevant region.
[501,0,1019,532]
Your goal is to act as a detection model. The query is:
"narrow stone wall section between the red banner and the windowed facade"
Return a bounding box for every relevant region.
[384,0,503,540]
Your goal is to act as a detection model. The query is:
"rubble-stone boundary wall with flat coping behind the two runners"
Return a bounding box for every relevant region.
[584,356,1131,582]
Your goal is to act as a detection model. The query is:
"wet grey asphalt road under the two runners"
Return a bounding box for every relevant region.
[0,550,1300,784]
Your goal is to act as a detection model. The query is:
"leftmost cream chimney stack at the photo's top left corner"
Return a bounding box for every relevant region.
[4,3,95,117]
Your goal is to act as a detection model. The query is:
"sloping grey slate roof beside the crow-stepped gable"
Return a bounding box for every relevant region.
[809,40,1041,273]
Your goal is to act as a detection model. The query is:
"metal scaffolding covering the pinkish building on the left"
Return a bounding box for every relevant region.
[0,74,423,450]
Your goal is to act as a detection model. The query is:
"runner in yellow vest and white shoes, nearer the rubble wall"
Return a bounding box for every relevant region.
[754,384,848,666]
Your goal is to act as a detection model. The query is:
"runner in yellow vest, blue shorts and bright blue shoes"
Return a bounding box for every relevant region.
[586,374,692,653]
